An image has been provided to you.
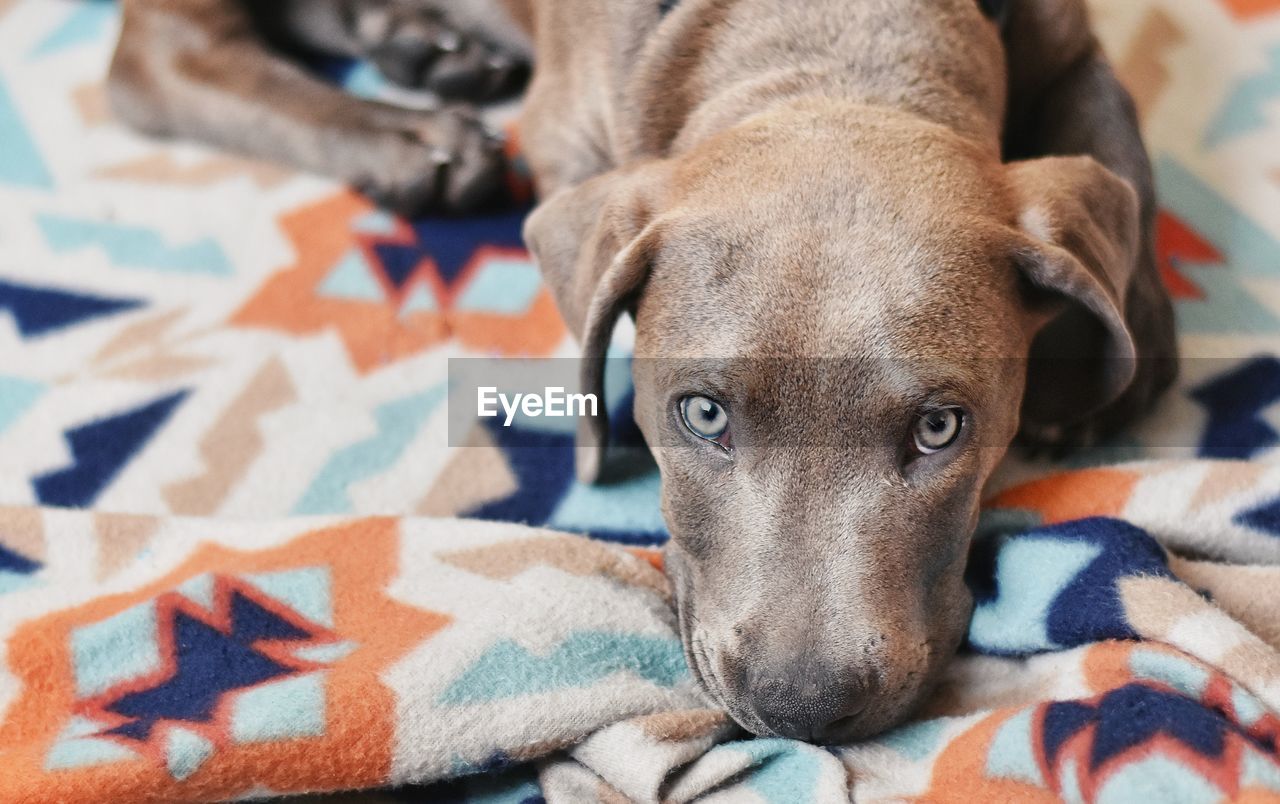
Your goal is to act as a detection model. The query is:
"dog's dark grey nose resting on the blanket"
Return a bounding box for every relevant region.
[746,664,876,743]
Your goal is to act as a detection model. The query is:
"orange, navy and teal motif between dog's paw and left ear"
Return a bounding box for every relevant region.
[232,195,564,373]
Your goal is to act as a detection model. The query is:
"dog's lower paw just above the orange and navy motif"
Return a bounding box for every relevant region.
[355,108,507,216]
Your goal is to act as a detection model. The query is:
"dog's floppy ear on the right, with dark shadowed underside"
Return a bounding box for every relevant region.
[1007,156,1142,426]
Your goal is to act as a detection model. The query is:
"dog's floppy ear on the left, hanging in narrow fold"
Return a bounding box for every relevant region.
[524,161,669,483]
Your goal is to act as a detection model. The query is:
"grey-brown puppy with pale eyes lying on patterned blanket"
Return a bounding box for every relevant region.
[109,0,1176,743]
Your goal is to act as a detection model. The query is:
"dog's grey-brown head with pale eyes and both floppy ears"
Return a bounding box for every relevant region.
[526,109,1138,740]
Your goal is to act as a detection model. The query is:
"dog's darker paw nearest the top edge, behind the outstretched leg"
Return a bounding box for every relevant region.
[369,10,530,102]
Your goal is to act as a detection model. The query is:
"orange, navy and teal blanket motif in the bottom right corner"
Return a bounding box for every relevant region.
[936,643,1280,801]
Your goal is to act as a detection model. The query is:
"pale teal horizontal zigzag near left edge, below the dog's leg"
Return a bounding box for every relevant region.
[36,214,232,277]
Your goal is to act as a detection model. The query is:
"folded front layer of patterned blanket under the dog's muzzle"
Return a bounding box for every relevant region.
[0,461,1280,803]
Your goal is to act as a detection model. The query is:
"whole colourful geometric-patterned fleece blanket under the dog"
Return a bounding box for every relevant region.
[0,0,1280,803]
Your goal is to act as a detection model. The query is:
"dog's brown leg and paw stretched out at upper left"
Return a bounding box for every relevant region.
[109,0,503,213]
